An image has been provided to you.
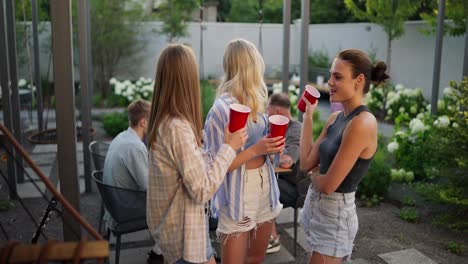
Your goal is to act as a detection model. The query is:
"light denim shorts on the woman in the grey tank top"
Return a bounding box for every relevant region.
[299,187,358,260]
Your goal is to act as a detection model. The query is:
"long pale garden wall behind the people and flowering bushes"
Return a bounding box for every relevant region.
[18,22,464,98]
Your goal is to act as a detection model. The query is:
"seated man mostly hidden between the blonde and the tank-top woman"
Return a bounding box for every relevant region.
[267,93,309,253]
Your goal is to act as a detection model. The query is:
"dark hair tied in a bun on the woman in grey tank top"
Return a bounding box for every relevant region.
[337,49,390,93]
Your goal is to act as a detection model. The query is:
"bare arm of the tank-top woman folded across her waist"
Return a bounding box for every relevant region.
[312,113,377,194]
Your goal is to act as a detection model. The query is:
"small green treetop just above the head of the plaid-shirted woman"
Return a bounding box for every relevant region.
[157,0,196,42]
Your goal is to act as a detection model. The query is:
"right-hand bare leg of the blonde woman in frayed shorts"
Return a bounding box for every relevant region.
[247,221,273,264]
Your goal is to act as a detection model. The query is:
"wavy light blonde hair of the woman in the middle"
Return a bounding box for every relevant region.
[218,39,268,121]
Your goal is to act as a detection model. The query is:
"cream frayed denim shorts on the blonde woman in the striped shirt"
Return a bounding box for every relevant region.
[216,163,283,236]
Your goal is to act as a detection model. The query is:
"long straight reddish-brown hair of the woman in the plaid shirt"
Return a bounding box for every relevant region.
[148,44,203,148]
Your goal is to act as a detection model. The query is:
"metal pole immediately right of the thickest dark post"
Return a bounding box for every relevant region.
[78,0,92,192]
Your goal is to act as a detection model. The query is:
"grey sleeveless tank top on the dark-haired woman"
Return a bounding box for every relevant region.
[319,105,373,193]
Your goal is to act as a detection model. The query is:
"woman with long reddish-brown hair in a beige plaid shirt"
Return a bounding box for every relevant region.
[147,44,247,264]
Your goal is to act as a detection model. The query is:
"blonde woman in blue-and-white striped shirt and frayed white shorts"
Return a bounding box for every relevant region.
[203,39,284,263]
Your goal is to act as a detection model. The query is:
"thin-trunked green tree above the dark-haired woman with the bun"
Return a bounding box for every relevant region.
[344,0,421,69]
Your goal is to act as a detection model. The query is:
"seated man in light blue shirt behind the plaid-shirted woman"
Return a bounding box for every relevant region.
[103,99,163,263]
